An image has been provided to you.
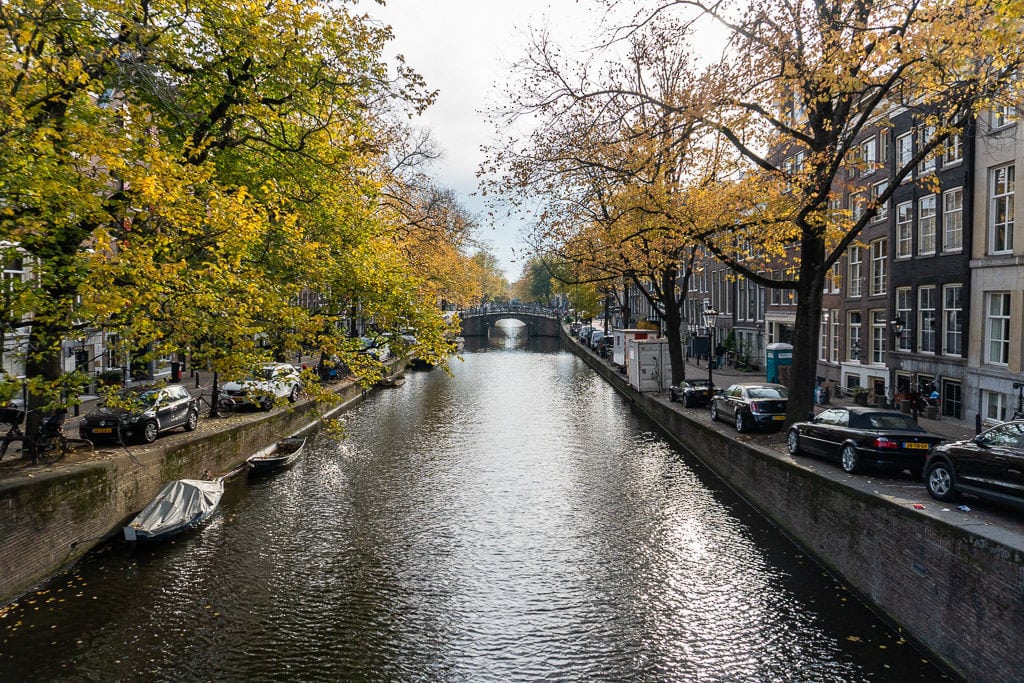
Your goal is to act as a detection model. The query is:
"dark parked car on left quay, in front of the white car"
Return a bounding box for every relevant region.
[78,384,199,443]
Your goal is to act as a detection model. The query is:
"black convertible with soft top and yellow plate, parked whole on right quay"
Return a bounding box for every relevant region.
[785,405,942,476]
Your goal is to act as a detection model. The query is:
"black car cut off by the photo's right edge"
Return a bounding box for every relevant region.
[925,420,1024,506]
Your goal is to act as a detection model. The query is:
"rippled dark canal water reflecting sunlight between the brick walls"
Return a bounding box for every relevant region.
[0,325,941,682]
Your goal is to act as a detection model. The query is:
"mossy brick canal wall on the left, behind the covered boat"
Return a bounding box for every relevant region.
[0,384,366,604]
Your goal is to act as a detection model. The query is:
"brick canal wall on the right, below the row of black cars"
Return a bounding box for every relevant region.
[563,327,1024,683]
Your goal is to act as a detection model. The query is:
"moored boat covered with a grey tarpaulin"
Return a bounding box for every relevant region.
[124,477,224,541]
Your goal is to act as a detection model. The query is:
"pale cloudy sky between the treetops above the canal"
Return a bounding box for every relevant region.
[360,0,600,281]
